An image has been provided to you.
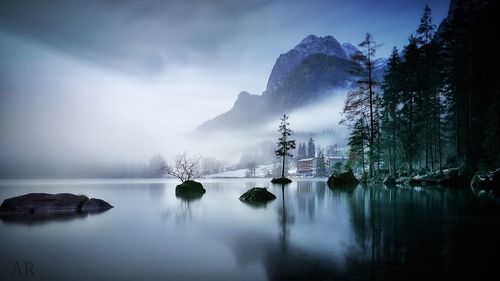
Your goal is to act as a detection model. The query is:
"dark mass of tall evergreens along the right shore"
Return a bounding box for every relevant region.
[342,1,500,176]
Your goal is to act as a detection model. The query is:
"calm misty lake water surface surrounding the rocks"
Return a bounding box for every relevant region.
[0,179,500,281]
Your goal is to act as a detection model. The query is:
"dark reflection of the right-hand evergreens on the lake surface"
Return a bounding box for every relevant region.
[234,181,500,280]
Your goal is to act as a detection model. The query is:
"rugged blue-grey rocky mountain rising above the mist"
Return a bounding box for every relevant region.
[196,35,386,133]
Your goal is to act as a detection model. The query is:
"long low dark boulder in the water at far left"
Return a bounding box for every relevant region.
[0,193,113,216]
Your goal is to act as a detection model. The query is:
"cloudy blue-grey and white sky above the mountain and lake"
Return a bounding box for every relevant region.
[0,0,449,166]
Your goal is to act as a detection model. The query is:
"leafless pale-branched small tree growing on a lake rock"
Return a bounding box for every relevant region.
[160,152,201,182]
